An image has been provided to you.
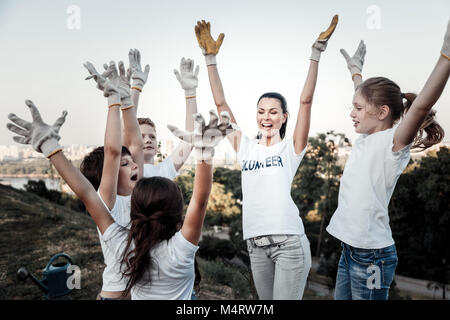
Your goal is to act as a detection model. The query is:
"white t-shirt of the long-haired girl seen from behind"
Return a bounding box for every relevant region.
[103,223,198,300]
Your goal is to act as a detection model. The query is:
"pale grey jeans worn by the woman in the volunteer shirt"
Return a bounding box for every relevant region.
[247,235,311,300]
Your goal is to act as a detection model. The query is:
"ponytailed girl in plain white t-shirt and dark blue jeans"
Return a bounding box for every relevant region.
[327,21,450,300]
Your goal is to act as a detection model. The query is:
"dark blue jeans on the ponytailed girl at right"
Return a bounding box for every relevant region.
[334,243,398,300]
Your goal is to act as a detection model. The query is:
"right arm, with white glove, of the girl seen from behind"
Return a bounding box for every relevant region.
[167,110,233,245]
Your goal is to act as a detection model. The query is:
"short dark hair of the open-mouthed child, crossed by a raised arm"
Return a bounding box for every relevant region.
[80,146,131,190]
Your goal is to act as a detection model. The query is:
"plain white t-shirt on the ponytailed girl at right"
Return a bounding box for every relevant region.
[327,128,411,249]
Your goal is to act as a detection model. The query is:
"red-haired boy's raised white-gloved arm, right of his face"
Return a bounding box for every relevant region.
[172,58,199,171]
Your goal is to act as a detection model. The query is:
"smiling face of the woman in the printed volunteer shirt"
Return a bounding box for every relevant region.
[256,98,287,139]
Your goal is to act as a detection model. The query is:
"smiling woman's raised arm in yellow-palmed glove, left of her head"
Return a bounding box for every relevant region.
[195,20,242,152]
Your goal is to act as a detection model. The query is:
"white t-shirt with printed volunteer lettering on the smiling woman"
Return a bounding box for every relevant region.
[237,134,306,240]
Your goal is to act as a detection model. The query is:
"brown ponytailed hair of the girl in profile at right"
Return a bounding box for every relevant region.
[357,77,445,150]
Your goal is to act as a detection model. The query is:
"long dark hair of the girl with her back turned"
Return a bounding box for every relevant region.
[121,177,184,297]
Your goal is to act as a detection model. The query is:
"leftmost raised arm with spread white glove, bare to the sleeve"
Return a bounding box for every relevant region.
[7,100,114,234]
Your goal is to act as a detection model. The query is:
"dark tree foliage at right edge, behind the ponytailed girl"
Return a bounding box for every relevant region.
[389,148,450,284]
